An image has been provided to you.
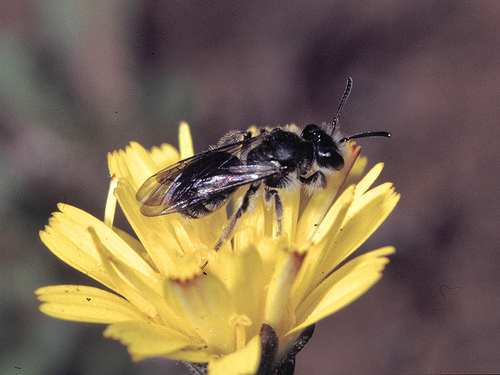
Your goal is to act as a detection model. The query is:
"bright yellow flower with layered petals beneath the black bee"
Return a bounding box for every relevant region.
[36,123,399,374]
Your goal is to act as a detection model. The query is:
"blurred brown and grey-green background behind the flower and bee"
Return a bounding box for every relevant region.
[0,0,500,375]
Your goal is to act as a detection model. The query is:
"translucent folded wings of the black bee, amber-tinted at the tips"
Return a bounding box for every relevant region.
[136,135,276,216]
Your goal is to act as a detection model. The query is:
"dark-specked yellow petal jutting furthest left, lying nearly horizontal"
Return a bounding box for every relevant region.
[35,285,147,324]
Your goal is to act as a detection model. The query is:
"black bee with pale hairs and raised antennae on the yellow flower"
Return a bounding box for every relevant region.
[136,78,391,250]
